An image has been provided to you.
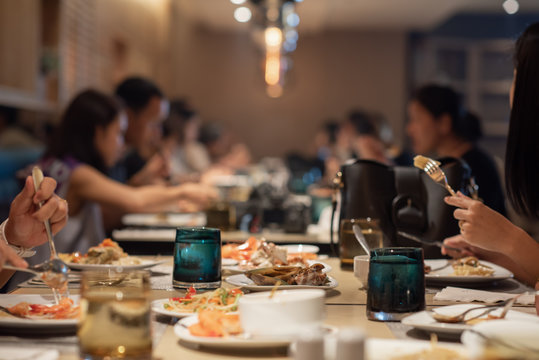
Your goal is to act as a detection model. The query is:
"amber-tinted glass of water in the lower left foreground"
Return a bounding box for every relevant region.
[77,267,152,360]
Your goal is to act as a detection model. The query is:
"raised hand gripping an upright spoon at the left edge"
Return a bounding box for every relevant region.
[0,176,67,288]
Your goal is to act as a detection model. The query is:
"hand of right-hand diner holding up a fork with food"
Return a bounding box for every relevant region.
[444,192,520,252]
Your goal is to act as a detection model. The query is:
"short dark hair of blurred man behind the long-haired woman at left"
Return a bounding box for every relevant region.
[116,77,164,112]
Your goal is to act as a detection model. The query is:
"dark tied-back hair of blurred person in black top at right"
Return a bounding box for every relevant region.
[412,84,483,143]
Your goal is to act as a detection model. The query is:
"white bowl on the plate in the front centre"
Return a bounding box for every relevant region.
[239,289,326,336]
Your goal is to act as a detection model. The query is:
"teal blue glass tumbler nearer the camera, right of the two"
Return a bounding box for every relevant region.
[367,247,425,321]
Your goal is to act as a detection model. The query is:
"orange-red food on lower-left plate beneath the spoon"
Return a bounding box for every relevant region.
[8,297,80,319]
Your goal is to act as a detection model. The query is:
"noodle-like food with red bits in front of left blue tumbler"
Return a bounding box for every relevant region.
[163,287,243,313]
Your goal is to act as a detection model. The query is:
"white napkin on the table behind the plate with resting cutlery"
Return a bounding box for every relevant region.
[434,286,535,305]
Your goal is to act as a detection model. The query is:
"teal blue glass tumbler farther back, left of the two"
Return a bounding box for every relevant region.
[172,227,221,289]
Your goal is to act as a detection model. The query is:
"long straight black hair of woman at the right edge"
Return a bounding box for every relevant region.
[505,23,539,217]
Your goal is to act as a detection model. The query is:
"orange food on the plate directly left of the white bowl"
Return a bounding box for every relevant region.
[188,309,242,337]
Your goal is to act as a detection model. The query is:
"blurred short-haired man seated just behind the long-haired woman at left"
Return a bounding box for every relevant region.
[111,77,169,186]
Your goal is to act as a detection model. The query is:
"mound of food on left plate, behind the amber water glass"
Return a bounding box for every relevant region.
[58,239,141,266]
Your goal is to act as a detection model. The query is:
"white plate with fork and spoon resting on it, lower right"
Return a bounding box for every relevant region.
[401,304,539,335]
